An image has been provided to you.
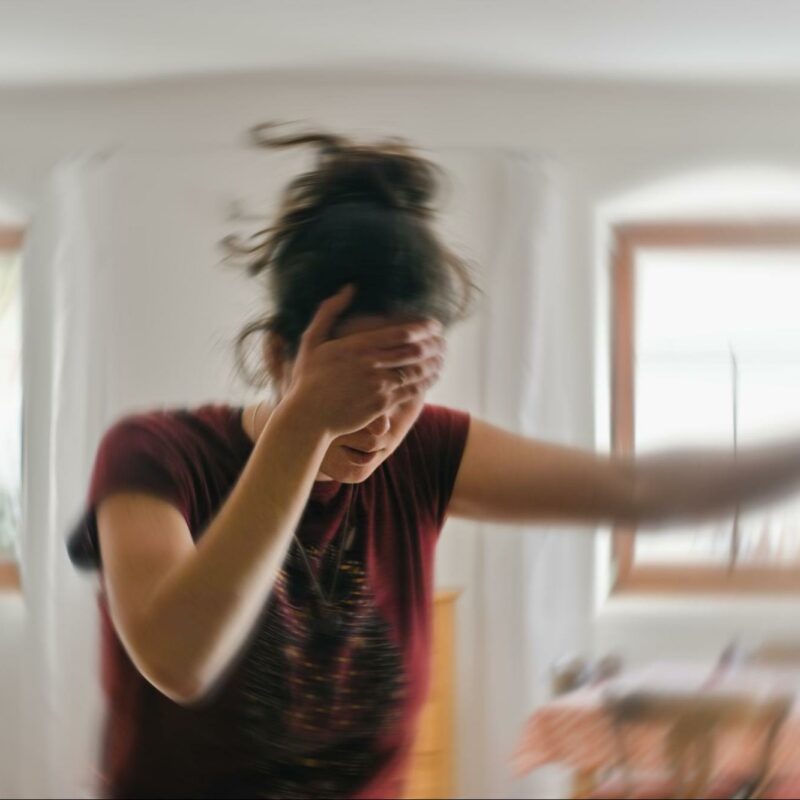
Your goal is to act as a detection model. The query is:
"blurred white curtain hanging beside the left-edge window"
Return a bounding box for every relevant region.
[19,159,109,797]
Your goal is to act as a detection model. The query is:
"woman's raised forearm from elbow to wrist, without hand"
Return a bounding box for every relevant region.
[135,399,330,702]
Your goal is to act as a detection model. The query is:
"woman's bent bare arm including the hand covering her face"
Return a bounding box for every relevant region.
[97,289,441,703]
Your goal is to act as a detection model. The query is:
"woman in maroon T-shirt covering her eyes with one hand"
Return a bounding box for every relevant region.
[70,126,800,797]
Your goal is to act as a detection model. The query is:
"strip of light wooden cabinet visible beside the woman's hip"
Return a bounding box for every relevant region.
[405,591,458,800]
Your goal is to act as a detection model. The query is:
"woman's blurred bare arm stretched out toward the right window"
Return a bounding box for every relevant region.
[450,419,800,525]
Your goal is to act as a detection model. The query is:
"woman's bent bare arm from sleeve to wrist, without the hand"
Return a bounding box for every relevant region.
[97,404,328,702]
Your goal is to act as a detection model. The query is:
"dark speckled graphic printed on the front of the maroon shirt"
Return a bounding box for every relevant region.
[220,542,405,798]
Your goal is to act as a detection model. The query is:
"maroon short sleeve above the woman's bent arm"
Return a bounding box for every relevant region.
[67,413,191,569]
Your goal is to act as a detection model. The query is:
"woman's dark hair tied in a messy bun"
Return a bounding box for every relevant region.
[226,123,475,385]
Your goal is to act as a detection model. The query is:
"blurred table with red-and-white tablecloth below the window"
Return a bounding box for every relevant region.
[515,662,800,797]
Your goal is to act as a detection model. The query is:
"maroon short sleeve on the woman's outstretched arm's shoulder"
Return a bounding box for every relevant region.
[413,404,470,527]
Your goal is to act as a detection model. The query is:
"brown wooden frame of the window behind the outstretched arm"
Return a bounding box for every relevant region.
[610,221,800,594]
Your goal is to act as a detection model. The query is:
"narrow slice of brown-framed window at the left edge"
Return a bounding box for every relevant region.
[0,228,22,589]
